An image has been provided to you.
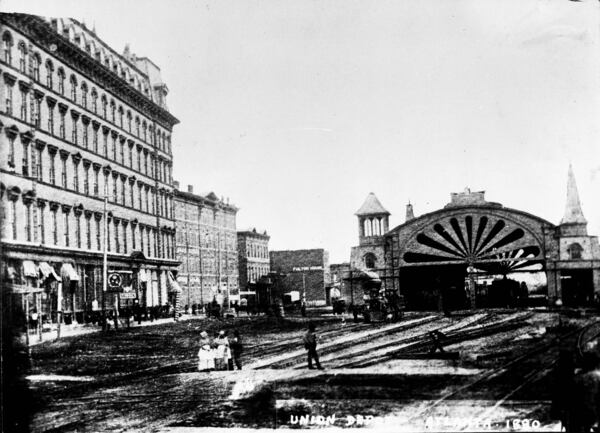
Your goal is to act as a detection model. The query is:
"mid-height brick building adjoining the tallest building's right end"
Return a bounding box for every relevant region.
[175,182,239,306]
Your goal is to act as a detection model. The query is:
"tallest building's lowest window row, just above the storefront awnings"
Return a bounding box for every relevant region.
[1,194,175,259]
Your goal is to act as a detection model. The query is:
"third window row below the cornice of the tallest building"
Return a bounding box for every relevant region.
[5,128,173,219]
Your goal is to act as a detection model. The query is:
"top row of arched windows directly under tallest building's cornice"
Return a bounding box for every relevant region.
[2,31,171,154]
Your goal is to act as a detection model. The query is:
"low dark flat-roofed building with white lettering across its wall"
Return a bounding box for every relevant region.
[270,249,331,306]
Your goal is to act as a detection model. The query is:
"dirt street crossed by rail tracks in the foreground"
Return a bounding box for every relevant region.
[21,311,596,432]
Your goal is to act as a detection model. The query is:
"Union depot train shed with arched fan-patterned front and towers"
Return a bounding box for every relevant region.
[346,167,600,310]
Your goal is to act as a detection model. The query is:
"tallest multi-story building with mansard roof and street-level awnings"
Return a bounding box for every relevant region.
[0,14,178,321]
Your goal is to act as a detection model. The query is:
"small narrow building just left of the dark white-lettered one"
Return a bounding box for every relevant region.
[237,228,271,296]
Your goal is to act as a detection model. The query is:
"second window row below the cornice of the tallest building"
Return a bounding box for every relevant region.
[4,75,172,184]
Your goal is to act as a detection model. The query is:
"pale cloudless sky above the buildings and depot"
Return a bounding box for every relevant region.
[0,0,600,263]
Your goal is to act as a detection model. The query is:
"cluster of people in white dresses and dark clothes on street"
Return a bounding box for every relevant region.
[198,329,243,371]
